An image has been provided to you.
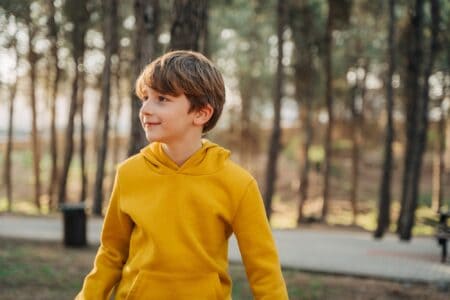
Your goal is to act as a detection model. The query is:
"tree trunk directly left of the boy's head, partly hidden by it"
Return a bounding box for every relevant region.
[128,0,159,155]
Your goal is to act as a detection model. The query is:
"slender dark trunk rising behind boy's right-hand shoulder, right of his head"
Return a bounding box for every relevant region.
[264,0,286,220]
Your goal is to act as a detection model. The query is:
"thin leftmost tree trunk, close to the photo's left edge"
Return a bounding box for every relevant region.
[3,41,19,212]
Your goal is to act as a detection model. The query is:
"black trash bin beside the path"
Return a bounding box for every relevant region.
[61,203,87,247]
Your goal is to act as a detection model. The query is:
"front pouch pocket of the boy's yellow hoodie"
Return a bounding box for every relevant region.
[126,271,223,300]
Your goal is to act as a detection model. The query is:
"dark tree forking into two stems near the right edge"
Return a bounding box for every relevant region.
[397,0,439,240]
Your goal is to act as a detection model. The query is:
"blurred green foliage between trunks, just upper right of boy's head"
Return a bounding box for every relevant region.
[209,0,276,111]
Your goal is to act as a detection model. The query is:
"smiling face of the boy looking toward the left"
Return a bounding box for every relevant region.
[139,87,202,144]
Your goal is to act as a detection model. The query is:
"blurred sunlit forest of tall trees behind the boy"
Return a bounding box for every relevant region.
[0,0,450,240]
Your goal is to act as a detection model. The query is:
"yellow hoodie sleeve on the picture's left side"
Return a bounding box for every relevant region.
[75,172,133,300]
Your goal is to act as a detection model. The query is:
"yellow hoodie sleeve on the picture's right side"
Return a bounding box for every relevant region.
[232,179,288,300]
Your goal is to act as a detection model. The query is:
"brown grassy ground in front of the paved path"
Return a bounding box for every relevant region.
[0,238,448,300]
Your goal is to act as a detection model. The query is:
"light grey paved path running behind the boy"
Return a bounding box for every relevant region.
[0,215,450,286]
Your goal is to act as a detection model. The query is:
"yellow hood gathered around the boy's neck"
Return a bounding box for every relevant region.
[141,139,230,175]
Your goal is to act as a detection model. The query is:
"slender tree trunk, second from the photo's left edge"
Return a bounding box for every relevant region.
[27,16,41,212]
